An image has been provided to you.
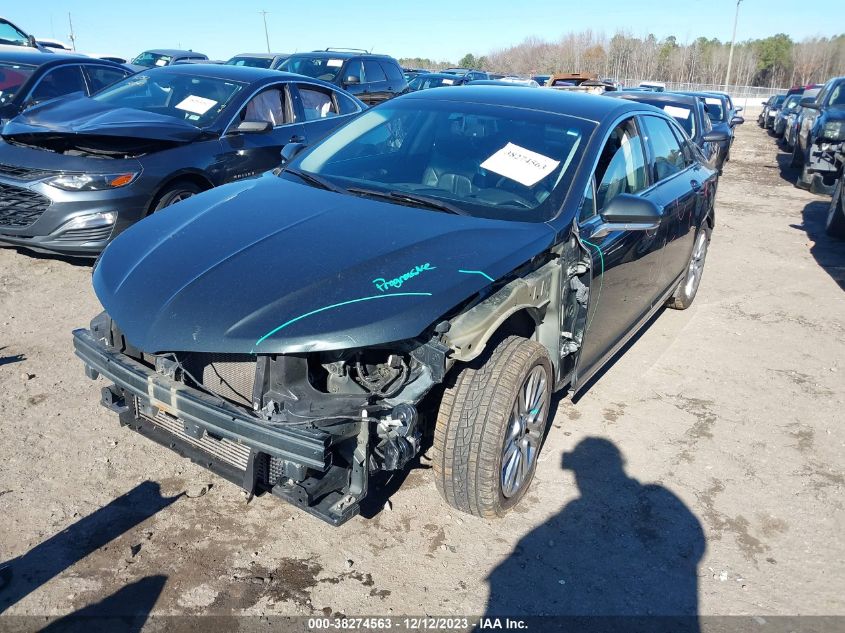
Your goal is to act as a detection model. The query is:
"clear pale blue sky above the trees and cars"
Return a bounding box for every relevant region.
[11,0,845,61]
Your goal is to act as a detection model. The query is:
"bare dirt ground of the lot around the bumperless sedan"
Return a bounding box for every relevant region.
[0,120,845,615]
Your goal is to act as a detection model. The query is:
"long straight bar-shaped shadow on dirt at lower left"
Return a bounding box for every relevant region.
[0,481,182,613]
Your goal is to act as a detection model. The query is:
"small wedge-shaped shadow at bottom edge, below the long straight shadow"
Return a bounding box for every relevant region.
[41,576,167,633]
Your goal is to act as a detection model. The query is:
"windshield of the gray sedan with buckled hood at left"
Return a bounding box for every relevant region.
[91,70,244,127]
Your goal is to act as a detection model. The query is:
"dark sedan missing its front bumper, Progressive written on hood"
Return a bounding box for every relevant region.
[74,86,716,525]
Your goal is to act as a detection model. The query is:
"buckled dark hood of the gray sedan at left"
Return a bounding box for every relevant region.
[3,94,203,143]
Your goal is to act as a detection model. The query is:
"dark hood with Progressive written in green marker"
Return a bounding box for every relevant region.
[94,174,555,354]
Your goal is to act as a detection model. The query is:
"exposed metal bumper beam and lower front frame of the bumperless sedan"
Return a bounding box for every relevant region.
[73,330,368,525]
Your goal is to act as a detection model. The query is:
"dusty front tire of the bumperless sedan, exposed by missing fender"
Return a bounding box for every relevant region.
[433,336,553,517]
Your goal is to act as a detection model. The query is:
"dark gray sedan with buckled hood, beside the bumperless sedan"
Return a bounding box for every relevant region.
[0,65,364,256]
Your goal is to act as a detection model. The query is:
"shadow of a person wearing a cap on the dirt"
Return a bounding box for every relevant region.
[485,437,706,633]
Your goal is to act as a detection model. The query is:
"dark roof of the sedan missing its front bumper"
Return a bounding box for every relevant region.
[396,86,652,122]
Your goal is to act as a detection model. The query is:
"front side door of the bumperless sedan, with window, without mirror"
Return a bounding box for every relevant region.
[576,117,664,384]
